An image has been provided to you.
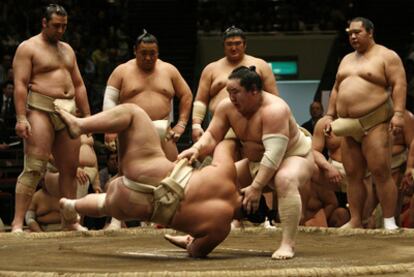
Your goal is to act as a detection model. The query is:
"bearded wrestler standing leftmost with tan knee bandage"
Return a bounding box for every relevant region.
[12,4,90,232]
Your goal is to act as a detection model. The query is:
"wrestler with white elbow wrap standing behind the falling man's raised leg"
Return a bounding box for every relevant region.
[103,30,193,161]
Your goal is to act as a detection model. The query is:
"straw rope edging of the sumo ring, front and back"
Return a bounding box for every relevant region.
[0,226,414,277]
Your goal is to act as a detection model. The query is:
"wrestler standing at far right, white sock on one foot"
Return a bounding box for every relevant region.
[327,17,407,229]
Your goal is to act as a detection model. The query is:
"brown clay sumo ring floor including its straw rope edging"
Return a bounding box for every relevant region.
[0,227,414,276]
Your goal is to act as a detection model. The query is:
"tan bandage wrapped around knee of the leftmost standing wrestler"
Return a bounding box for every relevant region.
[16,155,47,196]
